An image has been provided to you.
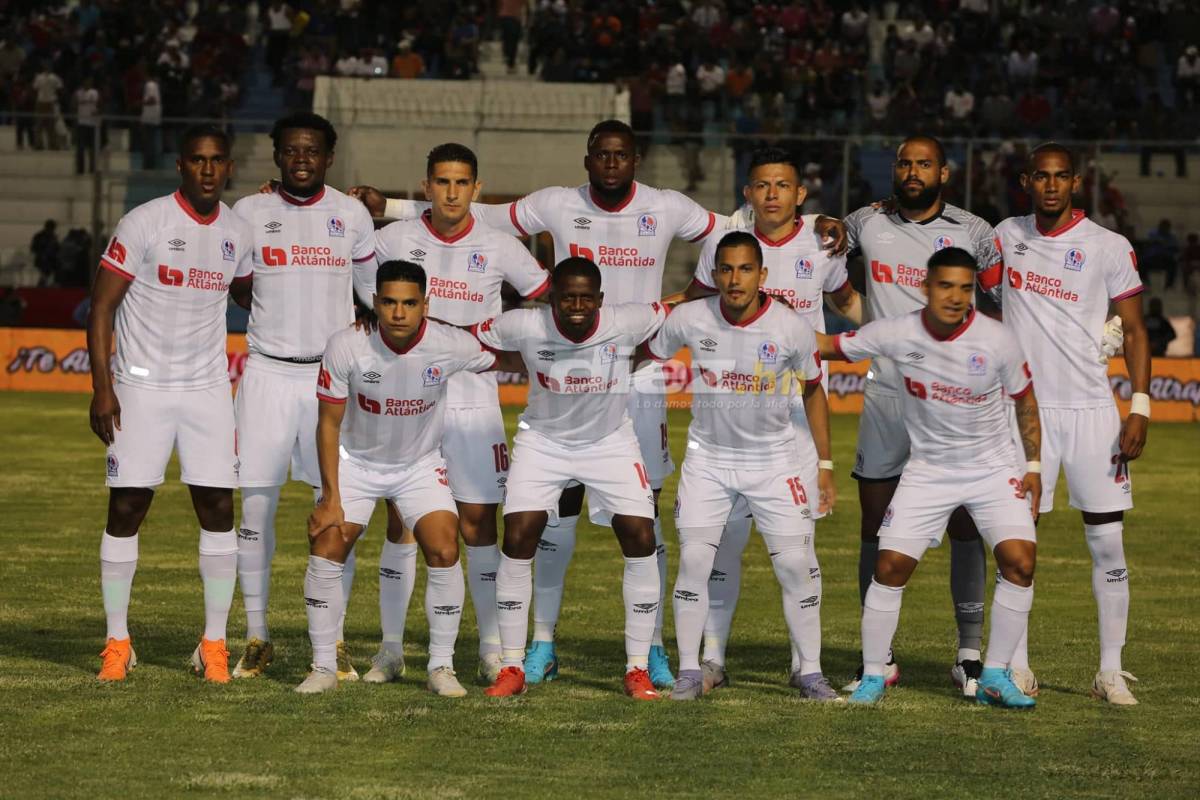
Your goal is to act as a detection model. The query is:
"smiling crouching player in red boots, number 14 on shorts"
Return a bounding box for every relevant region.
[476,257,667,700]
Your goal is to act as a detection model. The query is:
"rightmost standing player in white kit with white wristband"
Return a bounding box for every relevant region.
[996,144,1150,705]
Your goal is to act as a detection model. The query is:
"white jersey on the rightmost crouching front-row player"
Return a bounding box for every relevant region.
[834,308,1033,467]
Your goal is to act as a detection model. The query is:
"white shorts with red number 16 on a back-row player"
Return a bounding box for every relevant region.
[442,402,509,504]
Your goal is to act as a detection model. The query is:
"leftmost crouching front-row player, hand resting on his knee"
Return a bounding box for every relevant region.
[296,260,513,697]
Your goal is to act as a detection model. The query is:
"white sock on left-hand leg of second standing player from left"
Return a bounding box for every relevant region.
[238,486,281,642]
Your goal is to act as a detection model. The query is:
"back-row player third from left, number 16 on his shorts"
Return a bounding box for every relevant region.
[359,144,550,684]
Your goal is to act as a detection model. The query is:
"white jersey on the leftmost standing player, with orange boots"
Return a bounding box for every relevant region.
[100,192,253,389]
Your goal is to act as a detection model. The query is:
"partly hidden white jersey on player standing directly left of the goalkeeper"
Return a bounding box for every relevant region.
[692,218,850,333]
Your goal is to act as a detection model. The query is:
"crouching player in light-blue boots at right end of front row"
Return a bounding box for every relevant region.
[817,247,1041,708]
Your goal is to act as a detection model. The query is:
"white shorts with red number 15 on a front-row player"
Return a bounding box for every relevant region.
[674,458,816,537]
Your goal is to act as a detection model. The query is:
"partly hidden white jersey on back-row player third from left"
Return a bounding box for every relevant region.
[371,211,550,408]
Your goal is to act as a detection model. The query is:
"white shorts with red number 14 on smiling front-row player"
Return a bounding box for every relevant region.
[504,420,654,524]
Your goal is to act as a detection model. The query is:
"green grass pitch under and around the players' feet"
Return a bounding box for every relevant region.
[0,393,1200,799]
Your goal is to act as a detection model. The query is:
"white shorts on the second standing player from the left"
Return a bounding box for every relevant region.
[234,353,320,488]
